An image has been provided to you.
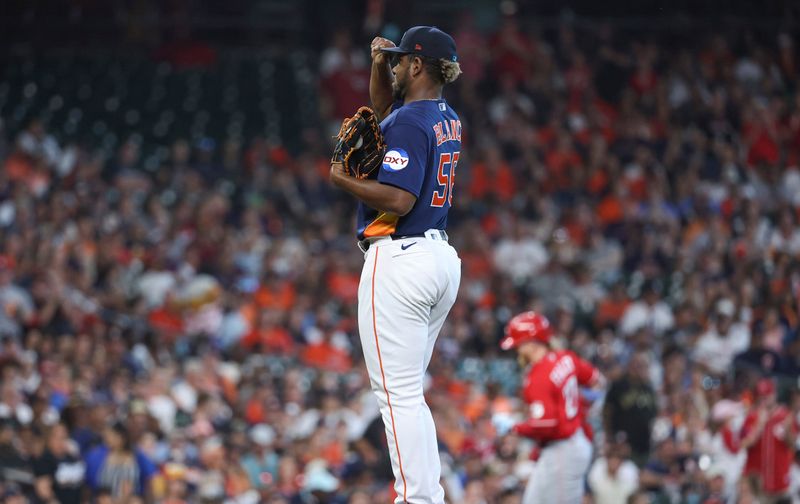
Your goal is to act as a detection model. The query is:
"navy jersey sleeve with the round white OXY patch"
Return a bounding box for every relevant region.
[378,122,430,198]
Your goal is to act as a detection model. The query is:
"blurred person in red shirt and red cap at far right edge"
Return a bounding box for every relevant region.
[741,378,797,503]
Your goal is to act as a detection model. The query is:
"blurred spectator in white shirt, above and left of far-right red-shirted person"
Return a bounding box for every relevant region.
[694,298,750,375]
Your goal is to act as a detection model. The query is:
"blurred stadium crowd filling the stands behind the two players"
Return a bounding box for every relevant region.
[0,10,800,504]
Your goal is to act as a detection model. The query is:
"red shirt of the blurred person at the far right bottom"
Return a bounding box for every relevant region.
[741,406,796,493]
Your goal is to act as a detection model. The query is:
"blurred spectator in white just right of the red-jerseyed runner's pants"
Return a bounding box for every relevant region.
[589,443,639,504]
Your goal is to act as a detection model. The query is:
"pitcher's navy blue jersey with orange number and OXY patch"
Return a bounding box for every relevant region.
[358,100,461,240]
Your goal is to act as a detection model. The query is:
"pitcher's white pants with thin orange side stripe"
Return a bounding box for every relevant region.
[358,233,461,504]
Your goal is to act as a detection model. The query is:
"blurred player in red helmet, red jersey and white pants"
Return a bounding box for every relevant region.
[500,311,603,504]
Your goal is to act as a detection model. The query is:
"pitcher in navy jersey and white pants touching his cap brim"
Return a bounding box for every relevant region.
[330,26,461,504]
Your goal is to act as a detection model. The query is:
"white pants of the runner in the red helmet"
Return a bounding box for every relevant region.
[522,429,592,504]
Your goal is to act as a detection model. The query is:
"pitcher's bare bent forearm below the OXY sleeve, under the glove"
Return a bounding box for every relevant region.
[330,163,417,217]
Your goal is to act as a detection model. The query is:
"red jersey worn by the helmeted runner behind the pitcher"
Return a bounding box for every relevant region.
[515,351,599,443]
